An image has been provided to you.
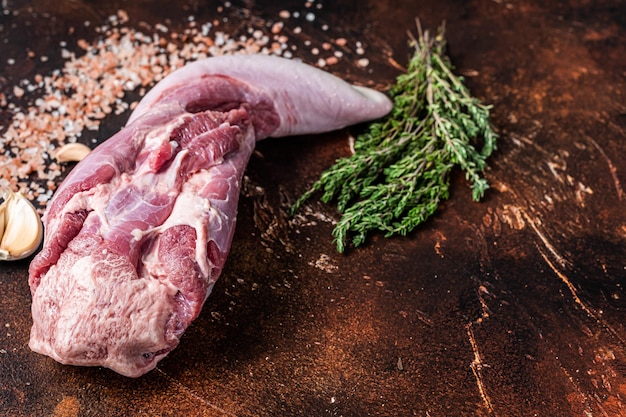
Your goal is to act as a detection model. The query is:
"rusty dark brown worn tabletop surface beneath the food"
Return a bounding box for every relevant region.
[0,0,626,417]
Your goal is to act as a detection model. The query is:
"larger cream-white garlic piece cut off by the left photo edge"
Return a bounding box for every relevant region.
[0,190,43,261]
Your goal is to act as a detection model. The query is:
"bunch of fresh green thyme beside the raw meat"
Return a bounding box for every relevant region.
[292,21,497,252]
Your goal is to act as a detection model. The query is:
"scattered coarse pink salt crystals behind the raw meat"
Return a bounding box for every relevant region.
[0,1,369,208]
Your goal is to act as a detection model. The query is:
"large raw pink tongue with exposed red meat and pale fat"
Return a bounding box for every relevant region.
[29,55,391,377]
